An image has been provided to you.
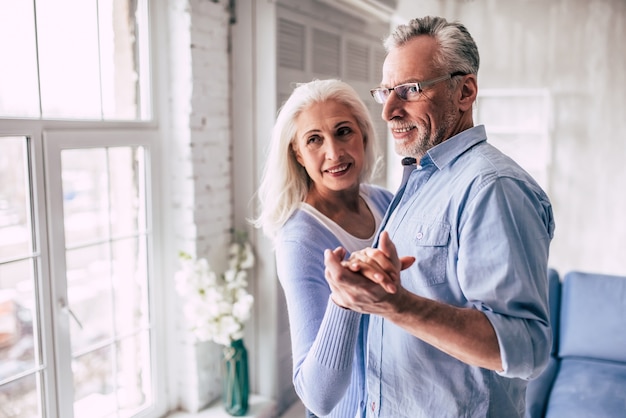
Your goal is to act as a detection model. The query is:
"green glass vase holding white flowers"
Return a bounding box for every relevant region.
[222,340,250,417]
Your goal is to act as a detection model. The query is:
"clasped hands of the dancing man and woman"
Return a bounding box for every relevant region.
[324,231,415,314]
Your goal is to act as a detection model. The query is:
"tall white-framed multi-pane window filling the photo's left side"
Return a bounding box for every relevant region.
[0,0,165,418]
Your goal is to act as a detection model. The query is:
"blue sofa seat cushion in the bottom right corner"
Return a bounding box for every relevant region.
[545,357,626,418]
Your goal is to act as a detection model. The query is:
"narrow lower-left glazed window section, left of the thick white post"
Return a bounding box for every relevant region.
[0,137,43,418]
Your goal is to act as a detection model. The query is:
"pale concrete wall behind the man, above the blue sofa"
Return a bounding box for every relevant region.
[397,0,626,275]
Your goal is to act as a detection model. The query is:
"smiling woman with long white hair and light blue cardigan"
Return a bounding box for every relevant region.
[255,80,391,418]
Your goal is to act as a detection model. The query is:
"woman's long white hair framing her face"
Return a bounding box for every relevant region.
[253,79,377,238]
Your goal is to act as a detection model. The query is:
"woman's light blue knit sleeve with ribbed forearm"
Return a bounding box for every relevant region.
[276,229,362,415]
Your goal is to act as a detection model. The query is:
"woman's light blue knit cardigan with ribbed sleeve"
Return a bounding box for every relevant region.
[275,185,392,418]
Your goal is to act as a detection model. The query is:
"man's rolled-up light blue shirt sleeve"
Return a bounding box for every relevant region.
[457,177,553,379]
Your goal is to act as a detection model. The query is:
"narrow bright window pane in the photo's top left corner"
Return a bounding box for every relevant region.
[0,0,39,118]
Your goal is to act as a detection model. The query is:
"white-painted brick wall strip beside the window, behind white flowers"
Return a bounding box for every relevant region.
[168,0,233,412]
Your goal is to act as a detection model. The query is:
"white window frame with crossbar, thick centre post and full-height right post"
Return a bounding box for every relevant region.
[0,2,168,412]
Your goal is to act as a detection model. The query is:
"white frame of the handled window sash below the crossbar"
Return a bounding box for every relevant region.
[42,128,166,417]
